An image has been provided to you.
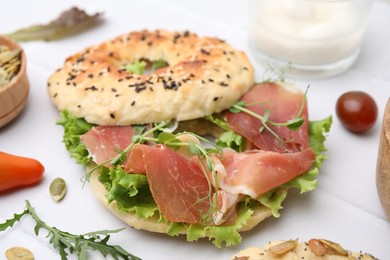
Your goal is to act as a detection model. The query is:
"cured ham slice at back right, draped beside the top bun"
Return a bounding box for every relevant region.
[226,83,309,152]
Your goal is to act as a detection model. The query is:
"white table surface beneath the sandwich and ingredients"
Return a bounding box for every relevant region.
[0,0,390,259]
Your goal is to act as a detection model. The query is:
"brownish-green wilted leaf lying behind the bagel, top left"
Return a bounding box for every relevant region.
[6,7,101,41]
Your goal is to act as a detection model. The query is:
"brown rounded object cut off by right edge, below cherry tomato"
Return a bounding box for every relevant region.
[376,98,390,221]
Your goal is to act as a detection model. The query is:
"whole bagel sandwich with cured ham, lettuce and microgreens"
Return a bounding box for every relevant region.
[48,30,332,247]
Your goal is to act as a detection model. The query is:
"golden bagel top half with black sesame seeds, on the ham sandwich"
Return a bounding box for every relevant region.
[48,30,254,125]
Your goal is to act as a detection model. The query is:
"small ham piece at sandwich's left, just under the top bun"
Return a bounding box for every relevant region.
[81,126,135,166]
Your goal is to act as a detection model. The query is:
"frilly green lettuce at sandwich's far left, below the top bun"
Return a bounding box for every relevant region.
[57,110,93,166]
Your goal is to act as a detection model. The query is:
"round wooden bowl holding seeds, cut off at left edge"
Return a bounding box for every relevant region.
[0,36,30,128]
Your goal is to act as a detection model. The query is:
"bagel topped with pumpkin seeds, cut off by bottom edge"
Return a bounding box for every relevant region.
[231,239,377,260]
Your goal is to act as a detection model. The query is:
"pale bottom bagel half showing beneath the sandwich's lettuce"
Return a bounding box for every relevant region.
[89,172,272,234]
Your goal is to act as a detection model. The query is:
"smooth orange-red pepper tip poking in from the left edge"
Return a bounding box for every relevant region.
[0,152,45,191]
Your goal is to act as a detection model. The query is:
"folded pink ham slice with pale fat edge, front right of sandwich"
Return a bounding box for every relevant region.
[218,148,316,199]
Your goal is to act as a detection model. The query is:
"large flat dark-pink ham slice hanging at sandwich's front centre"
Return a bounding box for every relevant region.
[133,144,212,223]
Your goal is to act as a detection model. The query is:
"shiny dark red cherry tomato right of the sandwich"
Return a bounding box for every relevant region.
[336,91,378,133]
